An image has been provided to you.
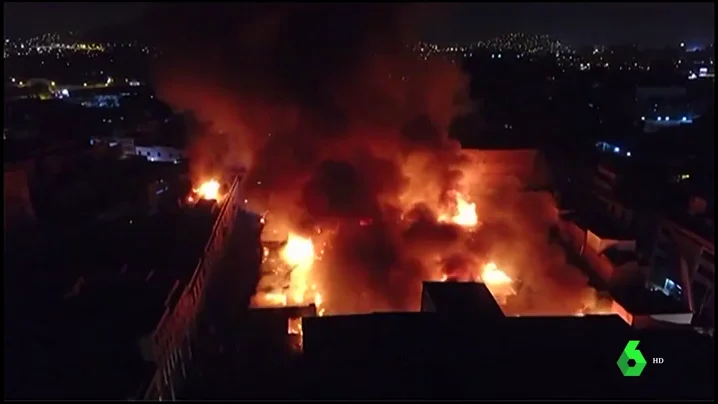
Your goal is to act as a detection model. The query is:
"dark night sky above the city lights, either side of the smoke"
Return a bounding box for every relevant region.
[3,2,715,46]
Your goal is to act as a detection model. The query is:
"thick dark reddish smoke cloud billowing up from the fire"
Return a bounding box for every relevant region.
[153,3,596,312]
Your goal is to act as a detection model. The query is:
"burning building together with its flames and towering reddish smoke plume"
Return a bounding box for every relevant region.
[156,4,612,314]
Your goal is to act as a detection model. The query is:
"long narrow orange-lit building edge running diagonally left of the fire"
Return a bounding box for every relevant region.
[143,174,242,400]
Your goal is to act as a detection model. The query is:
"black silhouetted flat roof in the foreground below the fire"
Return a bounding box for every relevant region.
[303,313,714,399]
